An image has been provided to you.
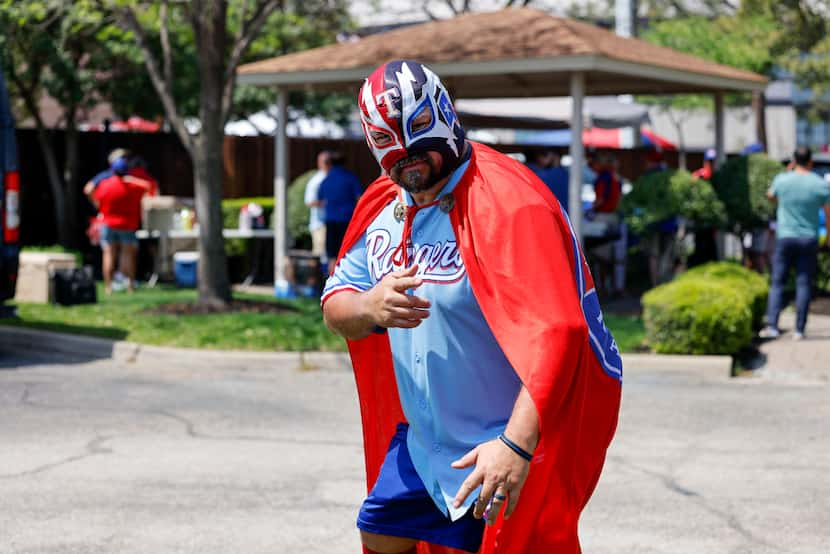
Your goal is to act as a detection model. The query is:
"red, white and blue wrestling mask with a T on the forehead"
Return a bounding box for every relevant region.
[358,60,464,178]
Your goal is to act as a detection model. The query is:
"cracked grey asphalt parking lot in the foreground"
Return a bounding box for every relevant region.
[0,340,830,554]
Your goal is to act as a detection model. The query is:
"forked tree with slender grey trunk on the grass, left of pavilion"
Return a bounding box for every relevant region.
[97,0,352,305]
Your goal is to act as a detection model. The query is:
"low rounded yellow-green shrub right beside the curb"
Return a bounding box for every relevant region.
[642,276,753,354]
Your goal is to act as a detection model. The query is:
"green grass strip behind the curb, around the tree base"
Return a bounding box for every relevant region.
[0,286,644,352]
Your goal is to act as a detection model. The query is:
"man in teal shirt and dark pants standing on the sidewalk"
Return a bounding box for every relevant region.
[760,146,830,340]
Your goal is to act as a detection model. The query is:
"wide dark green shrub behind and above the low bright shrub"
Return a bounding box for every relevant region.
[621,170,726,235]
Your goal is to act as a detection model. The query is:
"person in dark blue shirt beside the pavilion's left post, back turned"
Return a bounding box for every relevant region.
[317,152,363,272]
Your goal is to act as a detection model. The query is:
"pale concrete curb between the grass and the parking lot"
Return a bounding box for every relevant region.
[0,326,732,380]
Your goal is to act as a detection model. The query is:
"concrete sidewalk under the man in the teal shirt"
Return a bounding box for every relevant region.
[754,310,830,384]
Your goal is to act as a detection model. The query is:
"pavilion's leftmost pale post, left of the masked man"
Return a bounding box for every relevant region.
[274,89,293,297]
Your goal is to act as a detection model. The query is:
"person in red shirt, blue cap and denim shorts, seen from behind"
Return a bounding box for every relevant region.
[84,157,152,294]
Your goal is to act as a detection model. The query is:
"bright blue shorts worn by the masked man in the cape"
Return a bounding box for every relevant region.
[357,423,484,552]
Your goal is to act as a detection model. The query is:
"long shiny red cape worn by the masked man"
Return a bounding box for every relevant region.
[332,143,621,554]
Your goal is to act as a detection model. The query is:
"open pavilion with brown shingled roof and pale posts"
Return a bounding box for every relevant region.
[238,8,766,293]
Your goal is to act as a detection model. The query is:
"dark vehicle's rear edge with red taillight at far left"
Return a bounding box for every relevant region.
[0,67,20,305]
